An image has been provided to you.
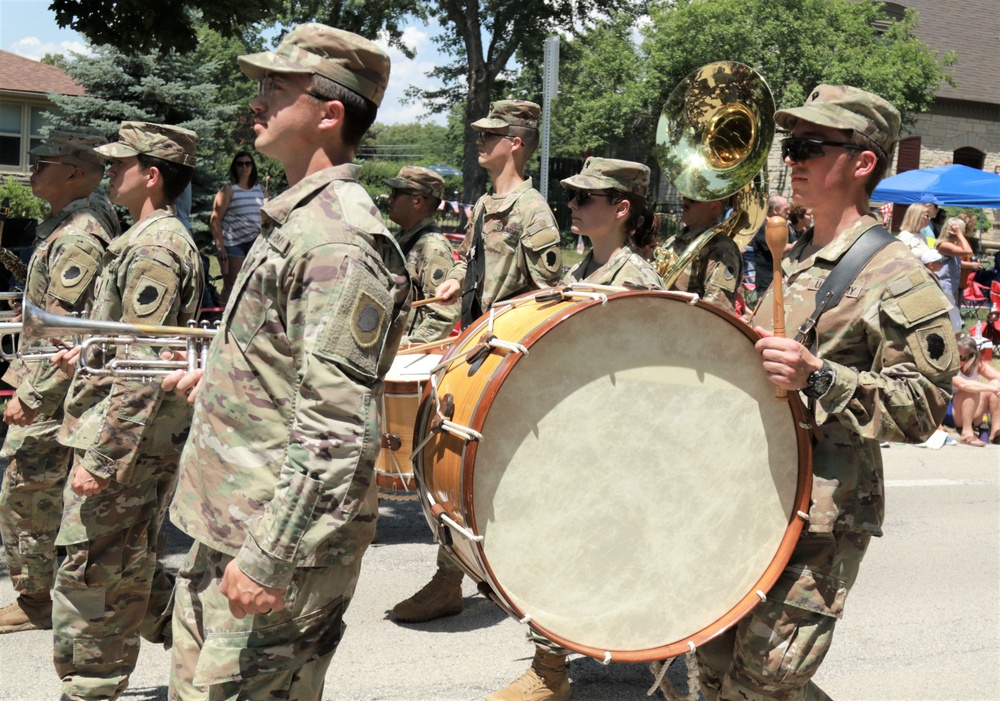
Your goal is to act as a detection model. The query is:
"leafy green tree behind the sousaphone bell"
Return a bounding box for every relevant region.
[553,0,954,180]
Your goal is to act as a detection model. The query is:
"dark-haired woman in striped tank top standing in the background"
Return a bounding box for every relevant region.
[210,151,267,306]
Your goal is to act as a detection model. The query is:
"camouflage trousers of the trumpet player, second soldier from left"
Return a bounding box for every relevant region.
[52,451,180,700]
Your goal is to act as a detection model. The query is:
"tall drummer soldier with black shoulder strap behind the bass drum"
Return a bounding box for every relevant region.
[392,100,562,623]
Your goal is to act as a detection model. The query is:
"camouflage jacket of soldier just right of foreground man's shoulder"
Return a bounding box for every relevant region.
[396,217,462,343]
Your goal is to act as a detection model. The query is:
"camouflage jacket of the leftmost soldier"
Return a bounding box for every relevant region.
[3,193,121,422]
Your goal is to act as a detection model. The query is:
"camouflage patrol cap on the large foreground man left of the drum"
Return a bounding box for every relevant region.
[237,22,389,106]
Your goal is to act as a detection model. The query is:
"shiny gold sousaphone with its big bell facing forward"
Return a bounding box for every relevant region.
[653,61,774,289]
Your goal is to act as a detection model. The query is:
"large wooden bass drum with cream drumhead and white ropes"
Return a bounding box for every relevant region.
[414,286,811,662]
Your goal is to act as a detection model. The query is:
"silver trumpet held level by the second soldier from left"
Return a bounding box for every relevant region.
[22,300,218,380]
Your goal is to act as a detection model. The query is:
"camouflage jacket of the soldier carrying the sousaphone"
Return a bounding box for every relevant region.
[664,225,743,313]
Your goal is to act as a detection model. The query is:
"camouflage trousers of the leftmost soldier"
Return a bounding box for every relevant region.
[0,421,73,594]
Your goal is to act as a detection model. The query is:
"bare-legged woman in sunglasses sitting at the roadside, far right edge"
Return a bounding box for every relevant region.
[951,336,1000,448]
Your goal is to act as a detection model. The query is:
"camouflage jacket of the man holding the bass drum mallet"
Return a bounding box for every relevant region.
[753,217,958,535]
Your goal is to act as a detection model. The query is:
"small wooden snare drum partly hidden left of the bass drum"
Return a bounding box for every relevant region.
[375,352,441,499]
